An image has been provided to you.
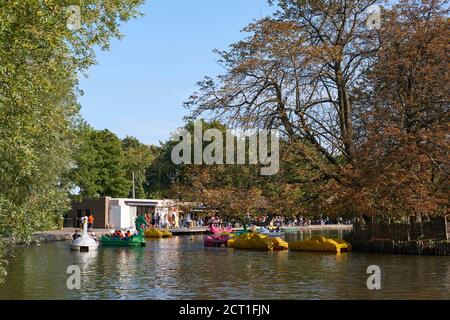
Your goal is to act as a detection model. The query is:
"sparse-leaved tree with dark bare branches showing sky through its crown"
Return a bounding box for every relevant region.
[186,0,377,188]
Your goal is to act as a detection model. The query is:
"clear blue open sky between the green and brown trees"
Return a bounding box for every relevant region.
[80,0,275,144]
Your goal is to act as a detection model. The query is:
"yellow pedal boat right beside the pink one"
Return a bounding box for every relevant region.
[228,233,288,251]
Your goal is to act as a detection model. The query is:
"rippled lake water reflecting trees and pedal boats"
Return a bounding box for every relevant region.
[0,232,450,299]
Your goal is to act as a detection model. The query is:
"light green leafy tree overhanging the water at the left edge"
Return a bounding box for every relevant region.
[0,0,142,280]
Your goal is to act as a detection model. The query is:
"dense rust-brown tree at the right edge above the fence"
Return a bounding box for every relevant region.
[342,0,450,217]
